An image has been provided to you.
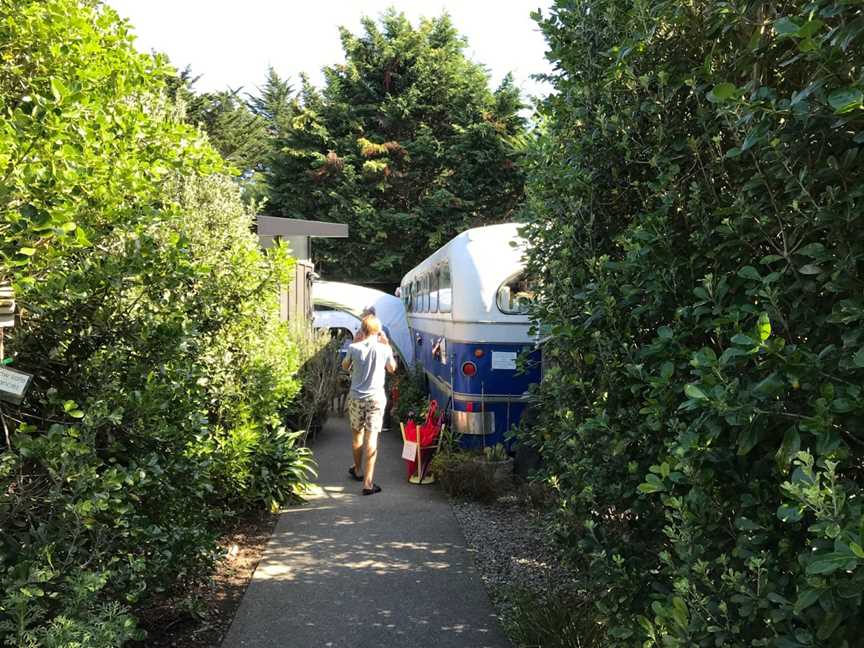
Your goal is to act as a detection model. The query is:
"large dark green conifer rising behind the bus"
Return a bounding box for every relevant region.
[262,10,526,283]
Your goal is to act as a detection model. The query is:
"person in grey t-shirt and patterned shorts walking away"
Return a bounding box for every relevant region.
[342,315,396,495]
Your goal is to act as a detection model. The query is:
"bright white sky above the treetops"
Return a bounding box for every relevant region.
[107,0,551,102]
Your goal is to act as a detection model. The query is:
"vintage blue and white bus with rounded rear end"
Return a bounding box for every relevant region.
[399,223,540,448]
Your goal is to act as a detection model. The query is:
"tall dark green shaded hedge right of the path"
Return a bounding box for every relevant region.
[527,0,864,648]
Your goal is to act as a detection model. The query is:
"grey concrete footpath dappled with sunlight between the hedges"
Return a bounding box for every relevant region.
[222,419,511,648]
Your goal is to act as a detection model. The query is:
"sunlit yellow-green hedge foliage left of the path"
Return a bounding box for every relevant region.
[0,0,310,648]
